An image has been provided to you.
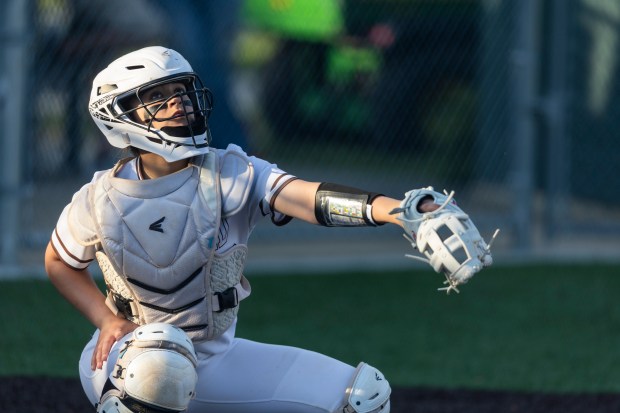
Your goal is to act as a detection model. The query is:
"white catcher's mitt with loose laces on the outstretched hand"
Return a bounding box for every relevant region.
[391,186,499,294]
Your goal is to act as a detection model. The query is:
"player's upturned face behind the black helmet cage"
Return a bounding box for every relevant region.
[136,82,194,125]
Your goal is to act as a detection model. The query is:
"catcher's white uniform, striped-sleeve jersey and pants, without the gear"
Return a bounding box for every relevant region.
[52,144,355,413]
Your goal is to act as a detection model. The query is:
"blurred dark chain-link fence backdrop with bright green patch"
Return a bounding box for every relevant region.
[0,0,620,277]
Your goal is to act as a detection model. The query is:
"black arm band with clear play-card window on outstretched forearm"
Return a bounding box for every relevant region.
[314,182,382,227]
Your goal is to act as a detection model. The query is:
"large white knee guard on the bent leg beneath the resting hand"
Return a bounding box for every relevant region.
[97,323,198,413]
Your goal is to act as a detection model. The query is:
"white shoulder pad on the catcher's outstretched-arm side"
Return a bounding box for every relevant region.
[220,144,254,217]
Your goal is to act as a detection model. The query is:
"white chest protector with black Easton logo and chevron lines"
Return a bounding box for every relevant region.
[89,152,253,341]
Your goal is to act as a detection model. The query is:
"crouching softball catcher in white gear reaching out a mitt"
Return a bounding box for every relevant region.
[45,46,492,413]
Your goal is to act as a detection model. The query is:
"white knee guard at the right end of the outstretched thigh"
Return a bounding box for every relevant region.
[342,363,392,413]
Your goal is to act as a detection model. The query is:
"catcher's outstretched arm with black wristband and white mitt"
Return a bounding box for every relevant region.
[274,180,498,293]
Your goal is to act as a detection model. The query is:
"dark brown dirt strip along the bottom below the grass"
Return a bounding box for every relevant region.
[0,377,620,413]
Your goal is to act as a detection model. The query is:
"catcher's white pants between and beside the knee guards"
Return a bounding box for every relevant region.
[79,325,355,413]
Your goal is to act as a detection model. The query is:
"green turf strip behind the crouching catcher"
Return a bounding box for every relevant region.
[0,265,620,392]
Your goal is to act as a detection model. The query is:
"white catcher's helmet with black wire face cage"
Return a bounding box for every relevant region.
[88,46,213,162]
